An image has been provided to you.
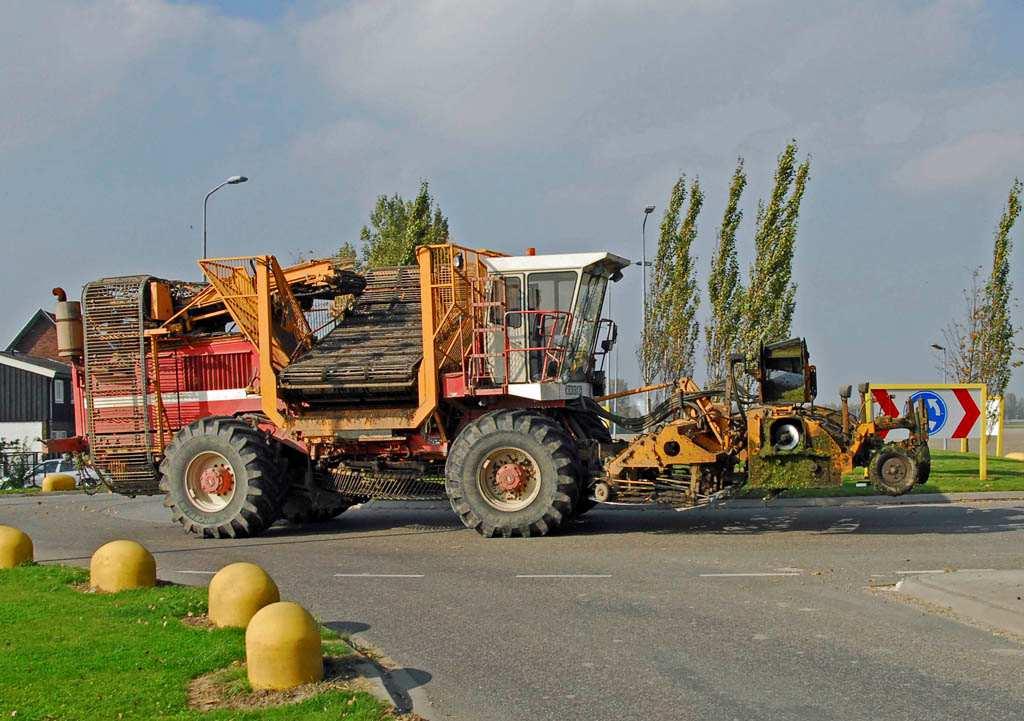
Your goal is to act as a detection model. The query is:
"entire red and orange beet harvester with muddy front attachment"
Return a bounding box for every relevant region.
[50,245,929,537]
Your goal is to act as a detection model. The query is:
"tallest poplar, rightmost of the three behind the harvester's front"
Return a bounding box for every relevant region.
[742,140,811,355]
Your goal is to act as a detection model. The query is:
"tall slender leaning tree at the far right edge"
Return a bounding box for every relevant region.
[981,178,1022,395]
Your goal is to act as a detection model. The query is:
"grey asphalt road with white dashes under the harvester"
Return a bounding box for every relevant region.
[6,496,1024,721]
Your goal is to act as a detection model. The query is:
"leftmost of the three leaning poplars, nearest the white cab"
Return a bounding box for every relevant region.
[637,175,703,384]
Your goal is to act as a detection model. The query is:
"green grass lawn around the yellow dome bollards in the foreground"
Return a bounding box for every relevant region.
[0,565,390,721]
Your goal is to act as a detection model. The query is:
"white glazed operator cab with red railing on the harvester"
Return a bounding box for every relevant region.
[471,253,630,400]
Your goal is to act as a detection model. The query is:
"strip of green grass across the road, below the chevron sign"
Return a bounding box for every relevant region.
[741,451,1024,498]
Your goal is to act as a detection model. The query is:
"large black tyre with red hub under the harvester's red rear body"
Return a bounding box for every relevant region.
[160,417,288,538]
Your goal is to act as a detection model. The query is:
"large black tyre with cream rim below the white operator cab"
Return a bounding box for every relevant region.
[444,410,579,538]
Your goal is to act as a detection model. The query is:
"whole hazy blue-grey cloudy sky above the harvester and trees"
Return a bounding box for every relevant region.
[0,0,1024,398]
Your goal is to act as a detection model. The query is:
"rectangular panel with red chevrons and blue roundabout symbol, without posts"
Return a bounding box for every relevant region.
[869,385,984,438]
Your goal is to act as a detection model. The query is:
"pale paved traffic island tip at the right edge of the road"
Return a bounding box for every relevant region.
[896,570,1024,638]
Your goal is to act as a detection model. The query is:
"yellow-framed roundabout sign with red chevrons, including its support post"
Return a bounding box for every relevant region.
[864,383,998,480]
